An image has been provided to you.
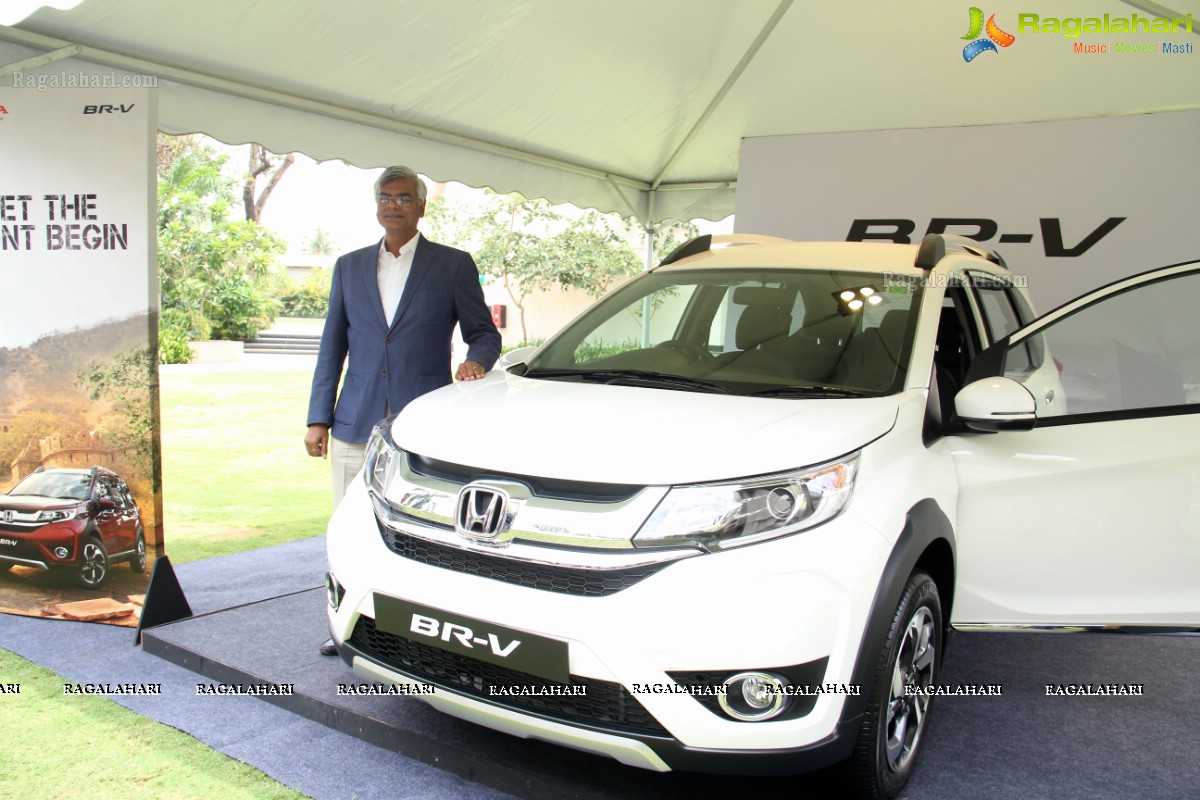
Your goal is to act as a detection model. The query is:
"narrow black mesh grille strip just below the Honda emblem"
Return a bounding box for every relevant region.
[377,527,668,597]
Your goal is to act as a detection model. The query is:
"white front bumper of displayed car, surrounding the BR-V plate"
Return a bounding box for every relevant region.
[328,472,887,774]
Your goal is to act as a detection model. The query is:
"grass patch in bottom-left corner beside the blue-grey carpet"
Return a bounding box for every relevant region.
[0,649,307,800]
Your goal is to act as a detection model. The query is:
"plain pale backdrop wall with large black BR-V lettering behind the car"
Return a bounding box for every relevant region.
[736,110,1200,311]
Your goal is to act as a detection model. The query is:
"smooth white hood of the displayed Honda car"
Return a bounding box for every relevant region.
[392,371,898,485]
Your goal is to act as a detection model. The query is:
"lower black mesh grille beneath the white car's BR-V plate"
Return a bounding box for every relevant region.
[350,616,670,736]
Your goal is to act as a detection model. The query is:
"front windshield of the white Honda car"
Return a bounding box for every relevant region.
[526,269,920,397]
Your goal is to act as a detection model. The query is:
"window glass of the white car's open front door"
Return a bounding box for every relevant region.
[1003,272,1200,415]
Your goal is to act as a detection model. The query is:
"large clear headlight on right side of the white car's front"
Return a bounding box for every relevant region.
[634,452,858,551]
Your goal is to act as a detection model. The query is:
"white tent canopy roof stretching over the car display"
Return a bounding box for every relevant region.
[0,0,1200,222]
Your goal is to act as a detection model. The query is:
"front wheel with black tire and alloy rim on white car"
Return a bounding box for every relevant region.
[851,572,942,800]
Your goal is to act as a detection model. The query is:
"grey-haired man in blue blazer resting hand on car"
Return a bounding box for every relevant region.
[305,167,500,506]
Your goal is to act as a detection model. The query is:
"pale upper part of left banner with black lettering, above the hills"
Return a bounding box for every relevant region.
[0,89,157,348]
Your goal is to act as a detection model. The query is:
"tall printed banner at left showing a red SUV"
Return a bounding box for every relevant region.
[0,88,163,626]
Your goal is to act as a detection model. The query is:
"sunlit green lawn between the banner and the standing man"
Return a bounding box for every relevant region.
[160,367,332,564]
